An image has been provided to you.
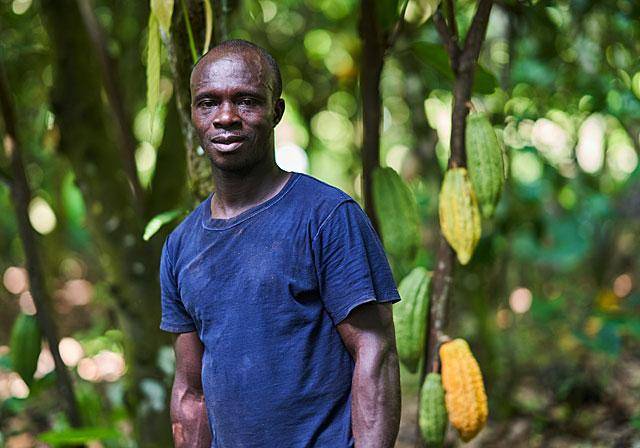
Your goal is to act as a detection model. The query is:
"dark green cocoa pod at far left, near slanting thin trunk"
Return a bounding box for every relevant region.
[10,314,42,386]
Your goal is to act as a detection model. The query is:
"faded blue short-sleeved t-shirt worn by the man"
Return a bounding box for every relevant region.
[160,173,399,448]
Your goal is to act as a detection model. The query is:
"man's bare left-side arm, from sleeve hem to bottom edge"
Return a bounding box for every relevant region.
[171,332,211,448]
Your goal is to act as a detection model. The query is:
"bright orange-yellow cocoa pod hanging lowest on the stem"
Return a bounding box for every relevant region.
[440,339,489,442]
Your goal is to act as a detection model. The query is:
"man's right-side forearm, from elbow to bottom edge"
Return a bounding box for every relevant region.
[351,347,400,448]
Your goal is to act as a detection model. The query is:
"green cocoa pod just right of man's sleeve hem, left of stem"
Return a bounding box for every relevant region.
[393,267,431,372]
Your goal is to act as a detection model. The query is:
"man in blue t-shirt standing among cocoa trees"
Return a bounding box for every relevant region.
[160,40,400,448]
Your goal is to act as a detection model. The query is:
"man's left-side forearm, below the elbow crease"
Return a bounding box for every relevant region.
[171,384,211,448]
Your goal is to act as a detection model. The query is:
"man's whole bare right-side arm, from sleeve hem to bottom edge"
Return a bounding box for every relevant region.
[337,303,400,448]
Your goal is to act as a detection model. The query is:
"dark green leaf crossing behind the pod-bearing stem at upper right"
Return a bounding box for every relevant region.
[411,41,498,94]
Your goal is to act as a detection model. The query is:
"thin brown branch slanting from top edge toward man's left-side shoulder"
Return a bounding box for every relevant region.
[77,0,144,213]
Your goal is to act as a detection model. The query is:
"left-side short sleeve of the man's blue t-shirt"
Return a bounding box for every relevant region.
[160,238,196,333]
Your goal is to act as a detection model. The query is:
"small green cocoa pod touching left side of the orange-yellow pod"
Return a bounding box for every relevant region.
[418,373,447,448]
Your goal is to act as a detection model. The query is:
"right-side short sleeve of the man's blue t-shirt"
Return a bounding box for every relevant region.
[312,200,400,325]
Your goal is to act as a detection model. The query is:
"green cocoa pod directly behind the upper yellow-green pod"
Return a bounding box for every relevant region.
[466,113,504,218]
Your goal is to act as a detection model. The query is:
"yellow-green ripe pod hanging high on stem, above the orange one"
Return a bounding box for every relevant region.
[438,168,482,264]
